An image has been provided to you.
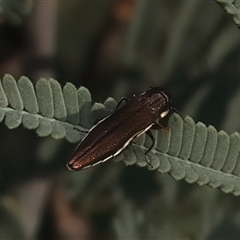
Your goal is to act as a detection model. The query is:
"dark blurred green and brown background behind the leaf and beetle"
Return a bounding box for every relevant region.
[0,0,240,240]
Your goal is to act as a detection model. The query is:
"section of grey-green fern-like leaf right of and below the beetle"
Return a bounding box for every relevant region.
[127,114,240,196]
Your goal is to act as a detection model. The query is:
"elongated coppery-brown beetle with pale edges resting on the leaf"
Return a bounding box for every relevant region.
[67,87,172,171]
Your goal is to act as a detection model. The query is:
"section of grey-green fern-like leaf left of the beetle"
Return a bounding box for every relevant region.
[0,74,115,143]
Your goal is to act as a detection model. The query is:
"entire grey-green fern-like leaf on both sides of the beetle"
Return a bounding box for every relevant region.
[0,74,240,195]
